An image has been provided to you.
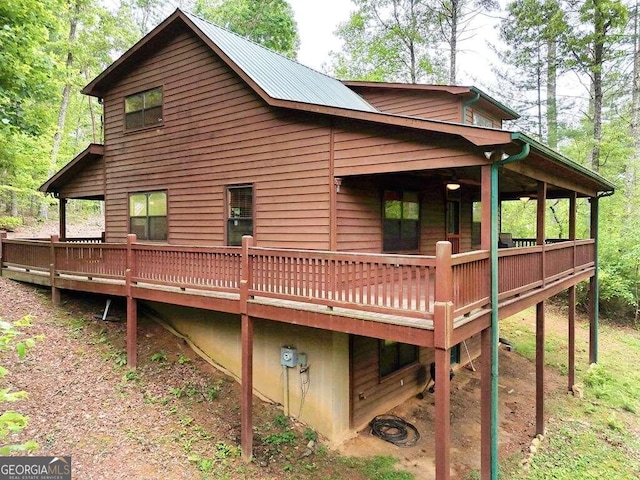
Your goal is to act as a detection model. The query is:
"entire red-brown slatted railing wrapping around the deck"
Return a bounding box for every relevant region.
[0,236,595,330]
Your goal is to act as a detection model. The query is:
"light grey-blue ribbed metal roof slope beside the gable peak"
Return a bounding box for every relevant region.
[183,12,378,112]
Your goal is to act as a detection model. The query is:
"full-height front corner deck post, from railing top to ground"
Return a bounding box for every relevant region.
[433,242,454,480]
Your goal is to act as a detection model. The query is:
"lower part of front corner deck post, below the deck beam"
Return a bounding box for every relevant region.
[434,348,451,480]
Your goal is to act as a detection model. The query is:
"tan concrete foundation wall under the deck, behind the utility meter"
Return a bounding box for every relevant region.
[144,303,350,442]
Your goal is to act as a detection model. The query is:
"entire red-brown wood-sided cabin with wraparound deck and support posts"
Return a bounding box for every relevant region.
[0,10,613,480]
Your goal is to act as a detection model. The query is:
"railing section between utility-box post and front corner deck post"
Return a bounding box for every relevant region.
[249,247,435,318]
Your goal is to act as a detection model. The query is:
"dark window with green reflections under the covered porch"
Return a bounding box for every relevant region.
[383,190,420,252]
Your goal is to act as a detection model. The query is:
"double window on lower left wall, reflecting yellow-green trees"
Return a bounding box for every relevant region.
[129,192,167,240]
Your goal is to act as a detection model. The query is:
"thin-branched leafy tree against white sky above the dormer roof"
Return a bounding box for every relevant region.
[331,0,446,83]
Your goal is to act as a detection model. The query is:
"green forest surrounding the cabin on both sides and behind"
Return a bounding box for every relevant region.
[0,0,640,327]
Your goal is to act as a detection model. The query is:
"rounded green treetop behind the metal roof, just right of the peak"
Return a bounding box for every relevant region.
[194,0,300,58]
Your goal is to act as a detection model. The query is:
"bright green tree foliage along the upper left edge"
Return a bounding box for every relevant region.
[0,0,62,215]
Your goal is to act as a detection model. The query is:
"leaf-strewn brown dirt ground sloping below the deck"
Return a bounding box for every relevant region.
[0,218,566,480]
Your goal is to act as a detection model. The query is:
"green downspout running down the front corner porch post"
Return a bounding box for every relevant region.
[491,143,531,480]
